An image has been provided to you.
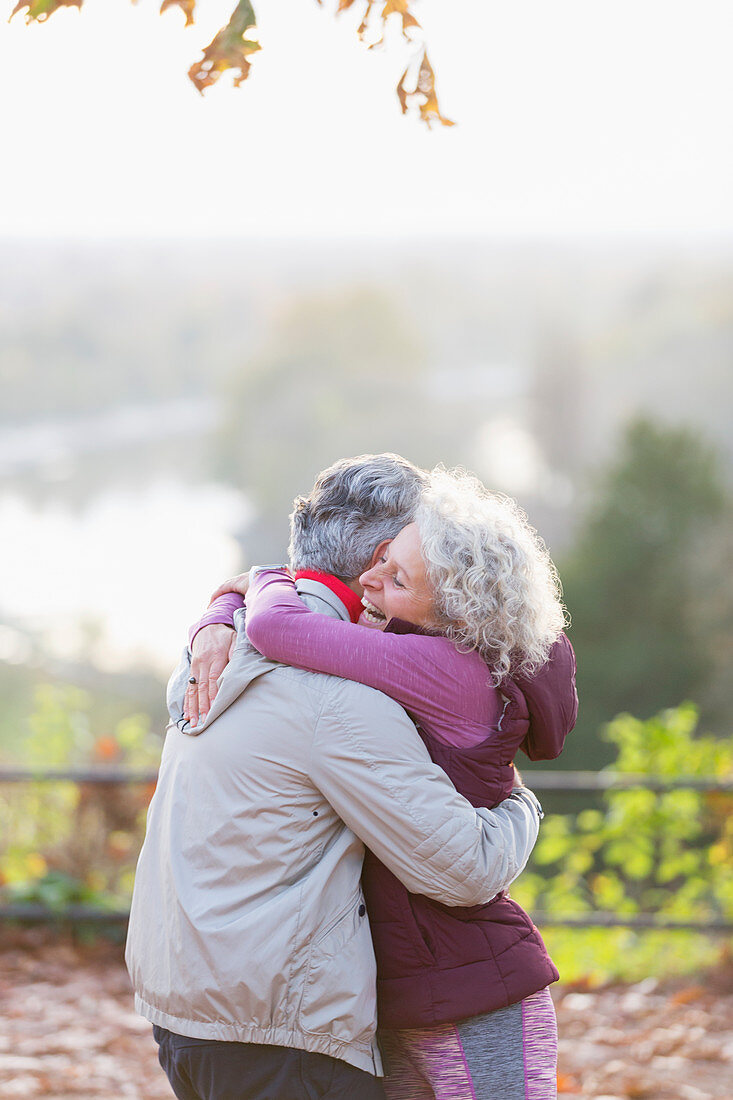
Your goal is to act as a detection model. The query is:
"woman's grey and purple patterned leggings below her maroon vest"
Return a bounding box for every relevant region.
[380,989,557,1100]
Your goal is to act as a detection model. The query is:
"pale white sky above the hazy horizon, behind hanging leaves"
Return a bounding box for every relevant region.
[0,0,733,238]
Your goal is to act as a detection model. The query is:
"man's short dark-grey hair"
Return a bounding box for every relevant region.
[288,454,427,580]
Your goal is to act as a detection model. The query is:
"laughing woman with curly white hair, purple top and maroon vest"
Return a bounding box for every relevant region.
[192,469,577,1100]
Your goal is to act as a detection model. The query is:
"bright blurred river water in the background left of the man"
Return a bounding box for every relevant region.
[0,403,251,673]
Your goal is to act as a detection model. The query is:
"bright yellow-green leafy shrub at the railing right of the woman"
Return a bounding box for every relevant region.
[512,704,733,978]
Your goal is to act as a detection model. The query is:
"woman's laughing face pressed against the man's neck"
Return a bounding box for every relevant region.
[359,524,435,627]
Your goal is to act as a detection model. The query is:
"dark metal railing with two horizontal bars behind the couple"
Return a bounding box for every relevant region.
[0,766,733,935]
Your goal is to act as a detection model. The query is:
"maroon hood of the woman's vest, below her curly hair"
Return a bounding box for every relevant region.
[515,634,578,760]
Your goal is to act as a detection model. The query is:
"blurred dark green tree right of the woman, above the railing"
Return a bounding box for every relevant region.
[558,419,733,768]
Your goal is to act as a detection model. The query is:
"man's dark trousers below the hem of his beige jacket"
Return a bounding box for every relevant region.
[153,1025,384,1100]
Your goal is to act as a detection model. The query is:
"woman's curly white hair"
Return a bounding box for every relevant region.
[415,466,566,685]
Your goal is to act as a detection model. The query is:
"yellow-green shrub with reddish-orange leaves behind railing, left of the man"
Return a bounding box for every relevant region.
[0,685,160,912]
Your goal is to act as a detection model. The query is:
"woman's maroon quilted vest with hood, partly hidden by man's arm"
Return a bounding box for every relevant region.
[362,637,578,1029]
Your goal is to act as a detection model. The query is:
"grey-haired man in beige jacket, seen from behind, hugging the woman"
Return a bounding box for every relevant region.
[127,455,540,1100]
